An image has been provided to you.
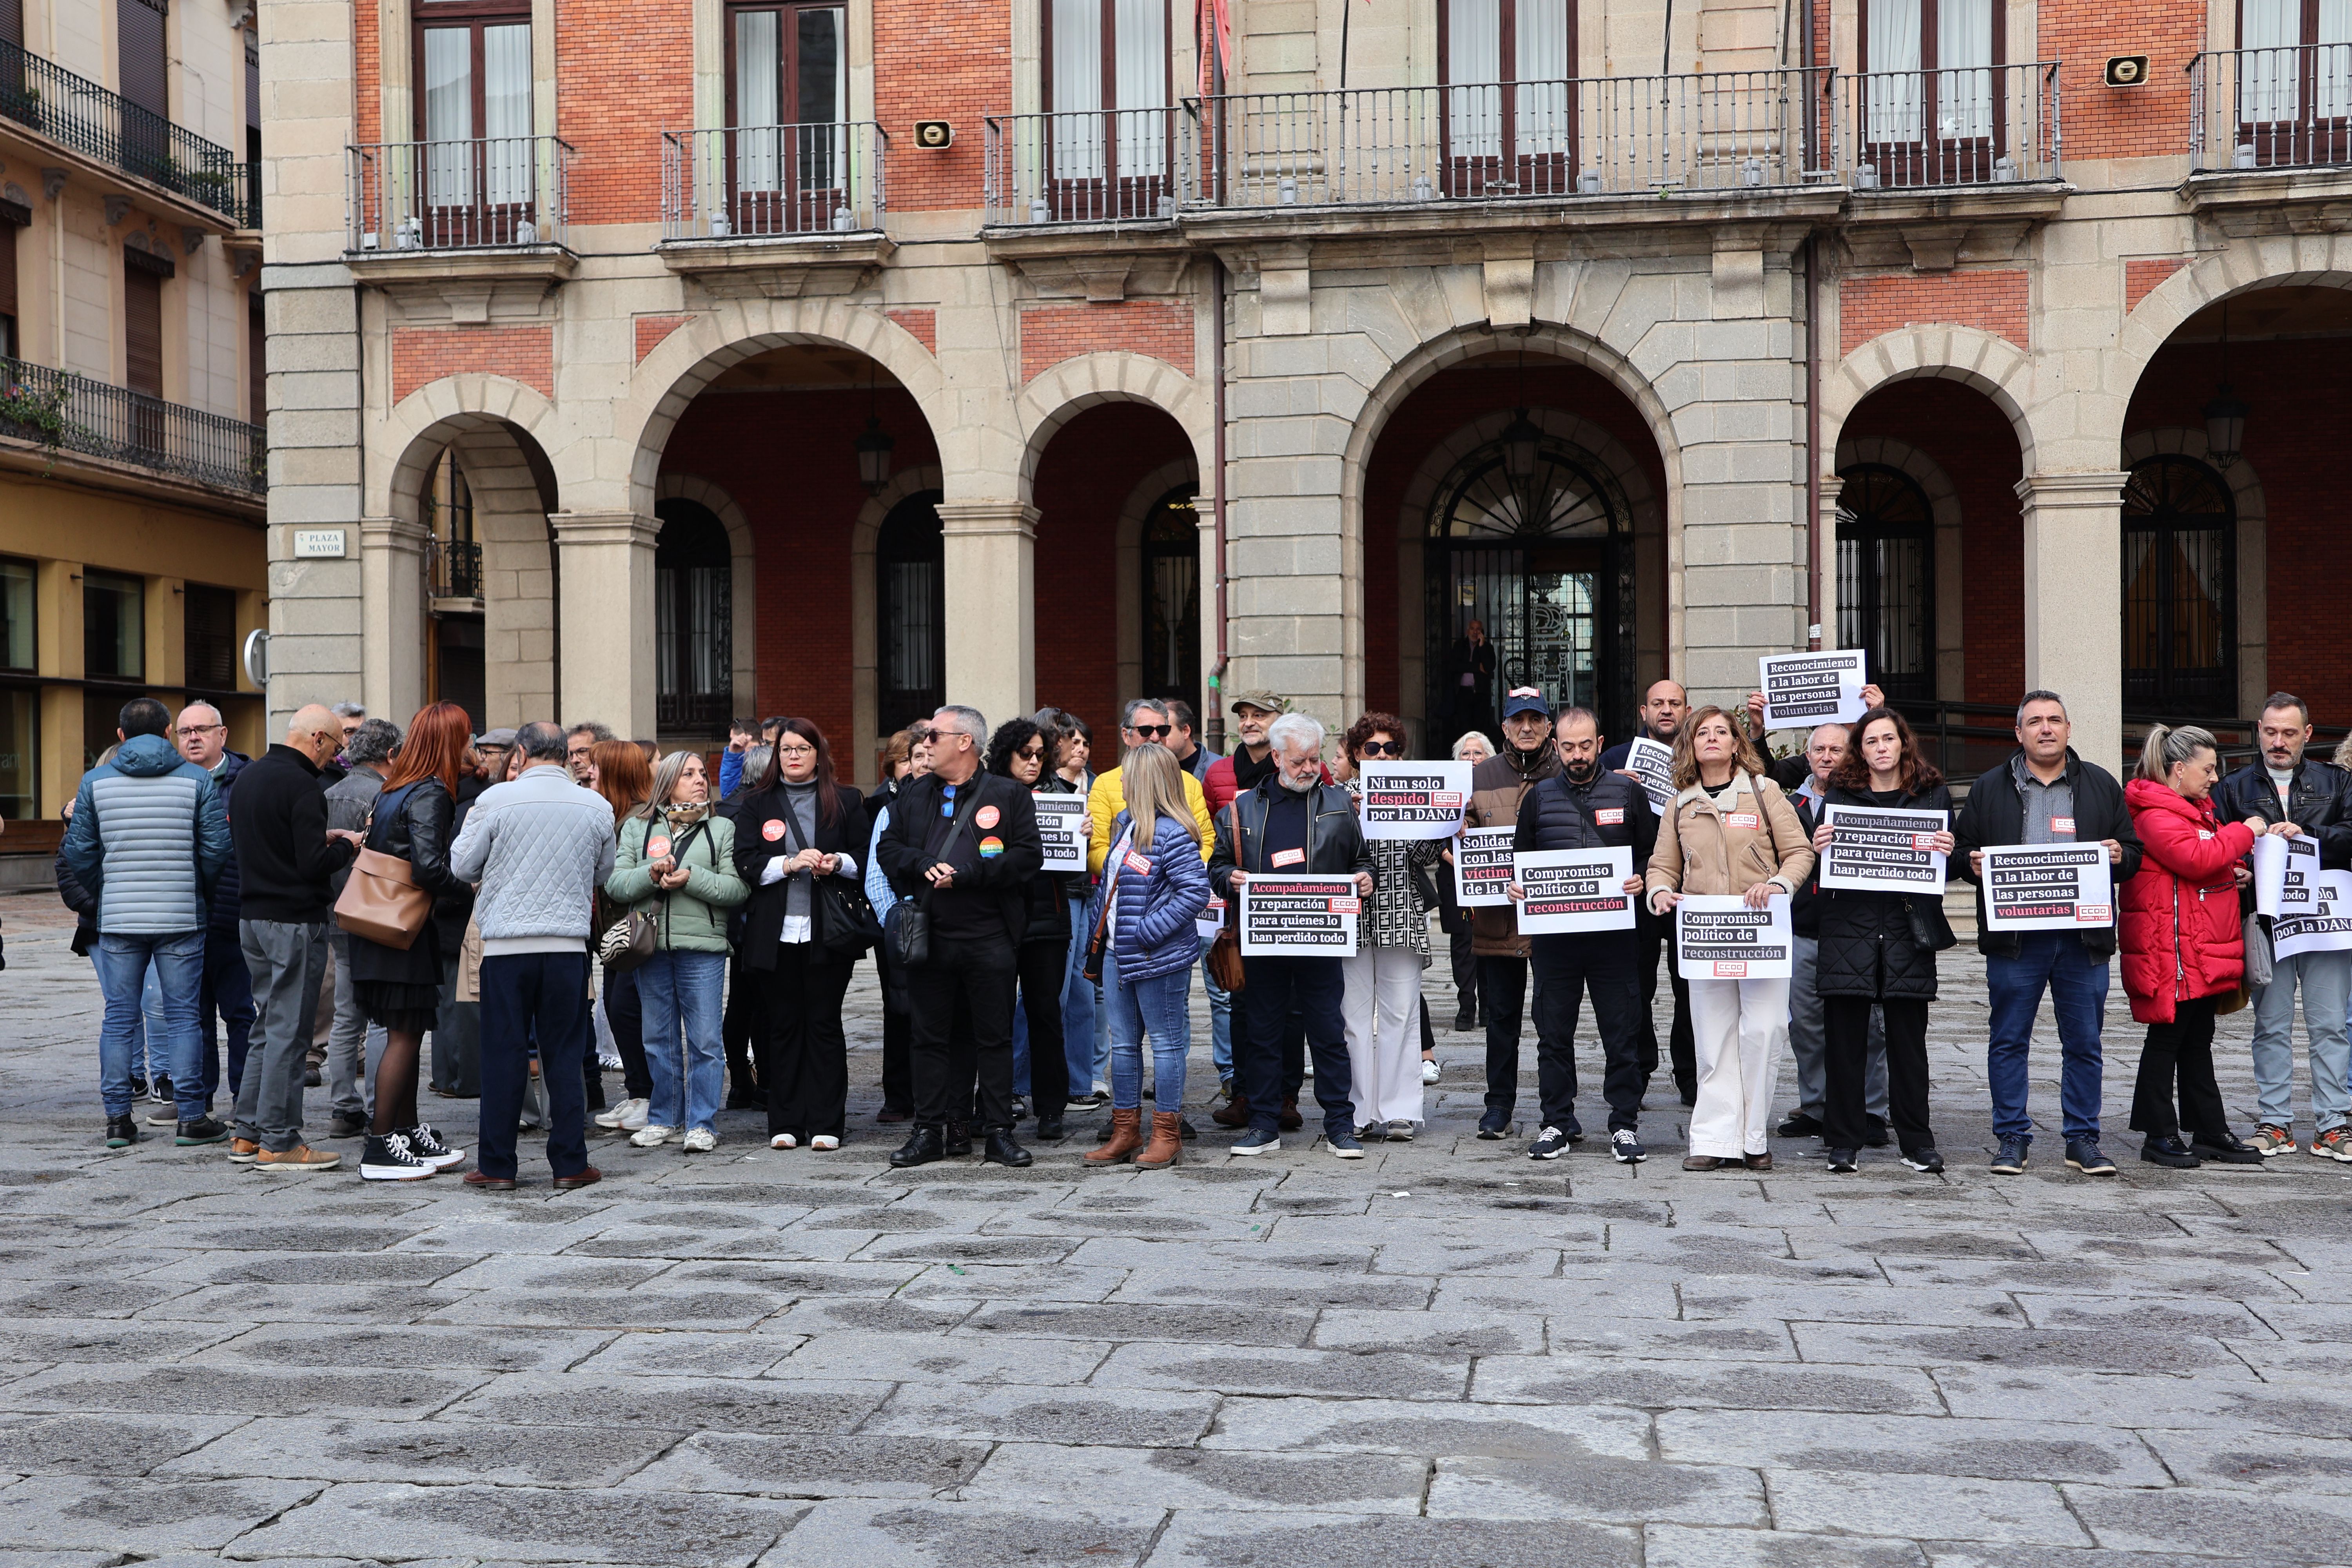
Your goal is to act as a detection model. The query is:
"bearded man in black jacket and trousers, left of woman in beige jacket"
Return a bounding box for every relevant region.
[1510,708,1658,1164]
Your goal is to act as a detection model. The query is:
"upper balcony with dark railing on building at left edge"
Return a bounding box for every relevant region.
[0,40,261,228]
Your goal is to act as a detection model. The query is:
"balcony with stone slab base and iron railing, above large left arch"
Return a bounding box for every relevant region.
[661,120,894,296]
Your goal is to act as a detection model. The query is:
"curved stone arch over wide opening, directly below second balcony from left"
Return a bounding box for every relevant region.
[621,299,978,512]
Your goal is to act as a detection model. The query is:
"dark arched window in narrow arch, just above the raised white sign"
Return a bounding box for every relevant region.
[1837,463,1936,698]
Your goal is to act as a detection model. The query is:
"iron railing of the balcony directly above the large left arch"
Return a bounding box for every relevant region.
[661,120,889,240]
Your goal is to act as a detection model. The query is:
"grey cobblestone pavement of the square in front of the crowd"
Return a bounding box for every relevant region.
[0,898,2352,1568]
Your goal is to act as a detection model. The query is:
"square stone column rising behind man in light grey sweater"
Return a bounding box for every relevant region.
[548,512,661,740]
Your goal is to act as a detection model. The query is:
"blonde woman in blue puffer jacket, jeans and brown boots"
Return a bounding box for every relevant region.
[1087,743,1209,1171]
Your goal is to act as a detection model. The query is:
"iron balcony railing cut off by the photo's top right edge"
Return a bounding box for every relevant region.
[2187,42,2352,174]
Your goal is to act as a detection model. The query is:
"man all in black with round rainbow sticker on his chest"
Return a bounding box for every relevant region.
[875,705,1044,1169]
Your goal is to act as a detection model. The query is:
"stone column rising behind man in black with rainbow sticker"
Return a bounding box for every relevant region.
[938,501,1037,726]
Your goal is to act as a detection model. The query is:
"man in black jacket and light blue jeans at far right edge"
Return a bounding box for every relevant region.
[2213,691,2352,1164]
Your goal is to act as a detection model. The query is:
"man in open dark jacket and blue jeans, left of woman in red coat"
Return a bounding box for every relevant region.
[1952,691,2140,1176]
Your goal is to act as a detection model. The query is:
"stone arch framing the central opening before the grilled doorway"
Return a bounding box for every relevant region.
[1338,322,1684,712]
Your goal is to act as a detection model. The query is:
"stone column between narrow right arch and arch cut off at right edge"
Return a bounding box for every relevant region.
[2018,472,2129,771]
